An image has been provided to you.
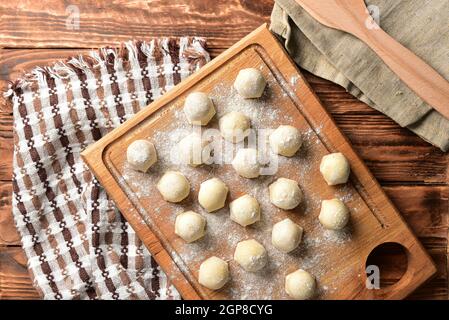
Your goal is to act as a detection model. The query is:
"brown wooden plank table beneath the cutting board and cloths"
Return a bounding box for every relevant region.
[0,0,449,299]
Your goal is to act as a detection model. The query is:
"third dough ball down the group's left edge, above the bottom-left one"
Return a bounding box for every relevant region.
[175,211,206,243]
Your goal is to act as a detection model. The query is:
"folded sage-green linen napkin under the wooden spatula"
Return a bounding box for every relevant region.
[270,0,449,151]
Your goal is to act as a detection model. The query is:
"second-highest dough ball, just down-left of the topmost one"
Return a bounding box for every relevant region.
[184,92,215,126]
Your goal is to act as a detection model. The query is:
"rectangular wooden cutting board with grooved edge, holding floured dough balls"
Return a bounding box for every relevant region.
[82,25,436,299]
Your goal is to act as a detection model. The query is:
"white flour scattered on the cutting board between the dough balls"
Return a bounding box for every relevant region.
[115,60,359,299]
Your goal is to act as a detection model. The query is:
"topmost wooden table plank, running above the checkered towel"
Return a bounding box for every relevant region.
[0,0,273,48]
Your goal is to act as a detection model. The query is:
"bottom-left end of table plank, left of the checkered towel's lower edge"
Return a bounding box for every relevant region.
[0,246,39,299]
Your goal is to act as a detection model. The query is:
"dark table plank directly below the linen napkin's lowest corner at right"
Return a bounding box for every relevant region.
[338,117,449,185]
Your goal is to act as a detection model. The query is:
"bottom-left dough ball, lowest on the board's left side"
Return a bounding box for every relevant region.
[198,256,230,290]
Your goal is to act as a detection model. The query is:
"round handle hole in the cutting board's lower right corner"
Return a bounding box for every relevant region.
[365,242,408,289]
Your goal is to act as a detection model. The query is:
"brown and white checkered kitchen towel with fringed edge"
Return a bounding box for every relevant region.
[5,37,209,299]
